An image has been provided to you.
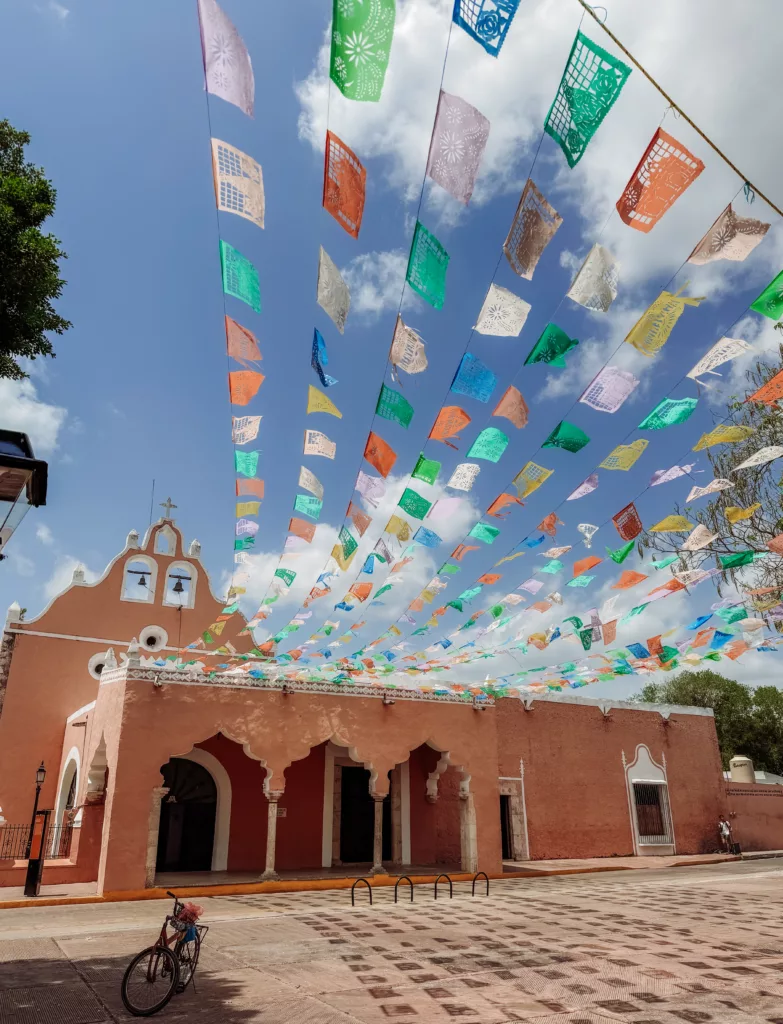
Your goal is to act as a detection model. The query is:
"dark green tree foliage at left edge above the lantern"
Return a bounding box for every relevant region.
[0,121,71,380]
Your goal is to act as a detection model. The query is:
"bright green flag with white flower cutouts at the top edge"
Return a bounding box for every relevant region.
[330,0,395,103]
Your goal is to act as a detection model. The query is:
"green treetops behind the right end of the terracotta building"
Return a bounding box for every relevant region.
[630,669,783,775]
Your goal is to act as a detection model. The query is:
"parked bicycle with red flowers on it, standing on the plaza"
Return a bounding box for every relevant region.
[121,890,209,1017]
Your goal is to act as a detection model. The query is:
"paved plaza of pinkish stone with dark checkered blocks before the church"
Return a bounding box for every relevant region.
[0,860,783,1024]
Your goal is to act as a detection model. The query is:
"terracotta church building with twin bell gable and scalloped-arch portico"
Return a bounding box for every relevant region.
[0,509,757,894]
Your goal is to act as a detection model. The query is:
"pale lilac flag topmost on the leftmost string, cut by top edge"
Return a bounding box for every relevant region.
[199,0,256,118]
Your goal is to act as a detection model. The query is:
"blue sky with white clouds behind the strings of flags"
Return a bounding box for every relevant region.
[0,0,783,693]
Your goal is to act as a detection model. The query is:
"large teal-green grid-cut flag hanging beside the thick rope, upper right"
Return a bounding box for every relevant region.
[543,32,630,167]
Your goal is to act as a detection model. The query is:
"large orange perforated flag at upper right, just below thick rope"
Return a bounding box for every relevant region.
[617,128,704,231]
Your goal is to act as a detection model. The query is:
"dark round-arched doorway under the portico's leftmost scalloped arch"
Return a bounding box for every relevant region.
[157,758,217,871]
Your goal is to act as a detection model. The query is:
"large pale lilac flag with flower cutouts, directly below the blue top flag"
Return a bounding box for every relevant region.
[427,89,489,204]
